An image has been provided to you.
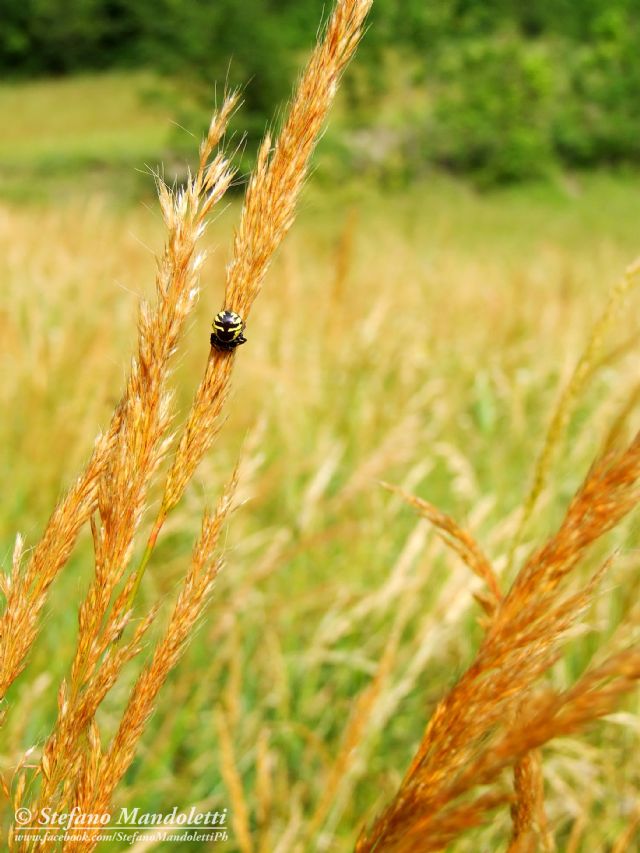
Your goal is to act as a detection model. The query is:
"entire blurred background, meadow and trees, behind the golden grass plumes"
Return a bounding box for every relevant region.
[0,0,640,853]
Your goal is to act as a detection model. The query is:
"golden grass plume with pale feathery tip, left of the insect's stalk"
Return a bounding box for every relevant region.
[11,96,237,846]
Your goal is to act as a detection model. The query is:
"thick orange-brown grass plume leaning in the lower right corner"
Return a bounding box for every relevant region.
[357,412,640,853]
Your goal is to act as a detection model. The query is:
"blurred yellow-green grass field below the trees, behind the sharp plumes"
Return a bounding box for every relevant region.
[0,75,640,853]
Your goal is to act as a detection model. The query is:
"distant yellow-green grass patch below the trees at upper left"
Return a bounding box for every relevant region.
[0,72,189,202]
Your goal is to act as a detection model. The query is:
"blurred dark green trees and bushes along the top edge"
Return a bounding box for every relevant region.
[0,0,640,183]
